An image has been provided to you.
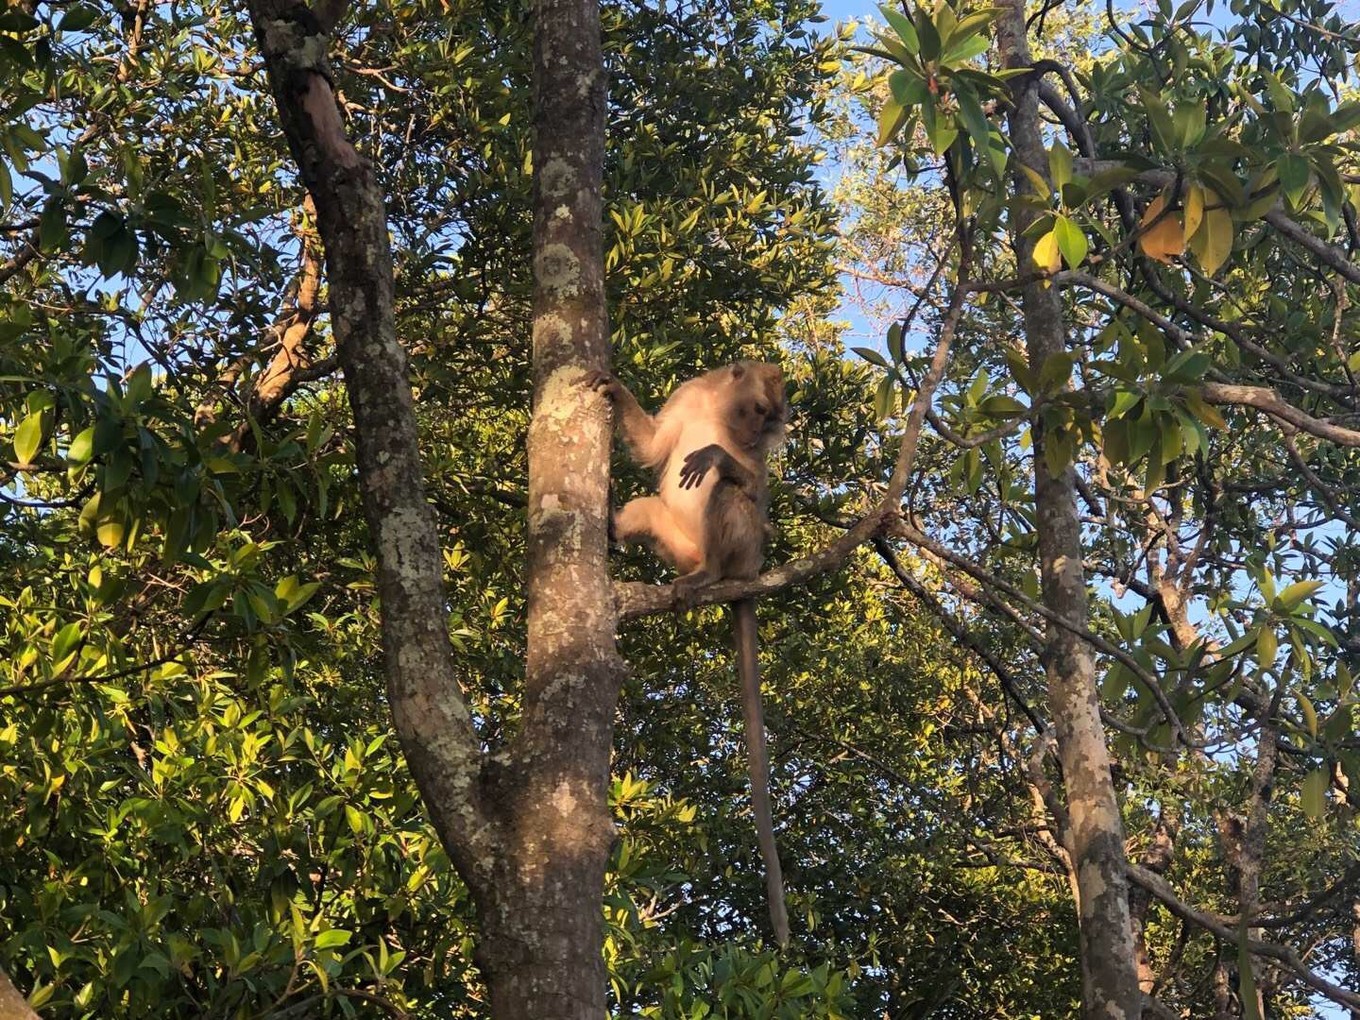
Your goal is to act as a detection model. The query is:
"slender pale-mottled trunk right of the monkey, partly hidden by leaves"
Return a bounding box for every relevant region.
[997,0,1142,1020]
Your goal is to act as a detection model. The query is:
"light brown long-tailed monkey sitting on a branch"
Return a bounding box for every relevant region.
[586,362,789,947]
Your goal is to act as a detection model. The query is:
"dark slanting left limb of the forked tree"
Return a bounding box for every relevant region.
[249,0,492,884]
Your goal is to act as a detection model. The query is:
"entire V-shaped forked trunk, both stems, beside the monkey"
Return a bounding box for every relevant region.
[249,0,623,1020]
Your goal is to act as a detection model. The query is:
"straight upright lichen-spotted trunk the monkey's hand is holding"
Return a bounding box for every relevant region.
[470,0,623,1020]
